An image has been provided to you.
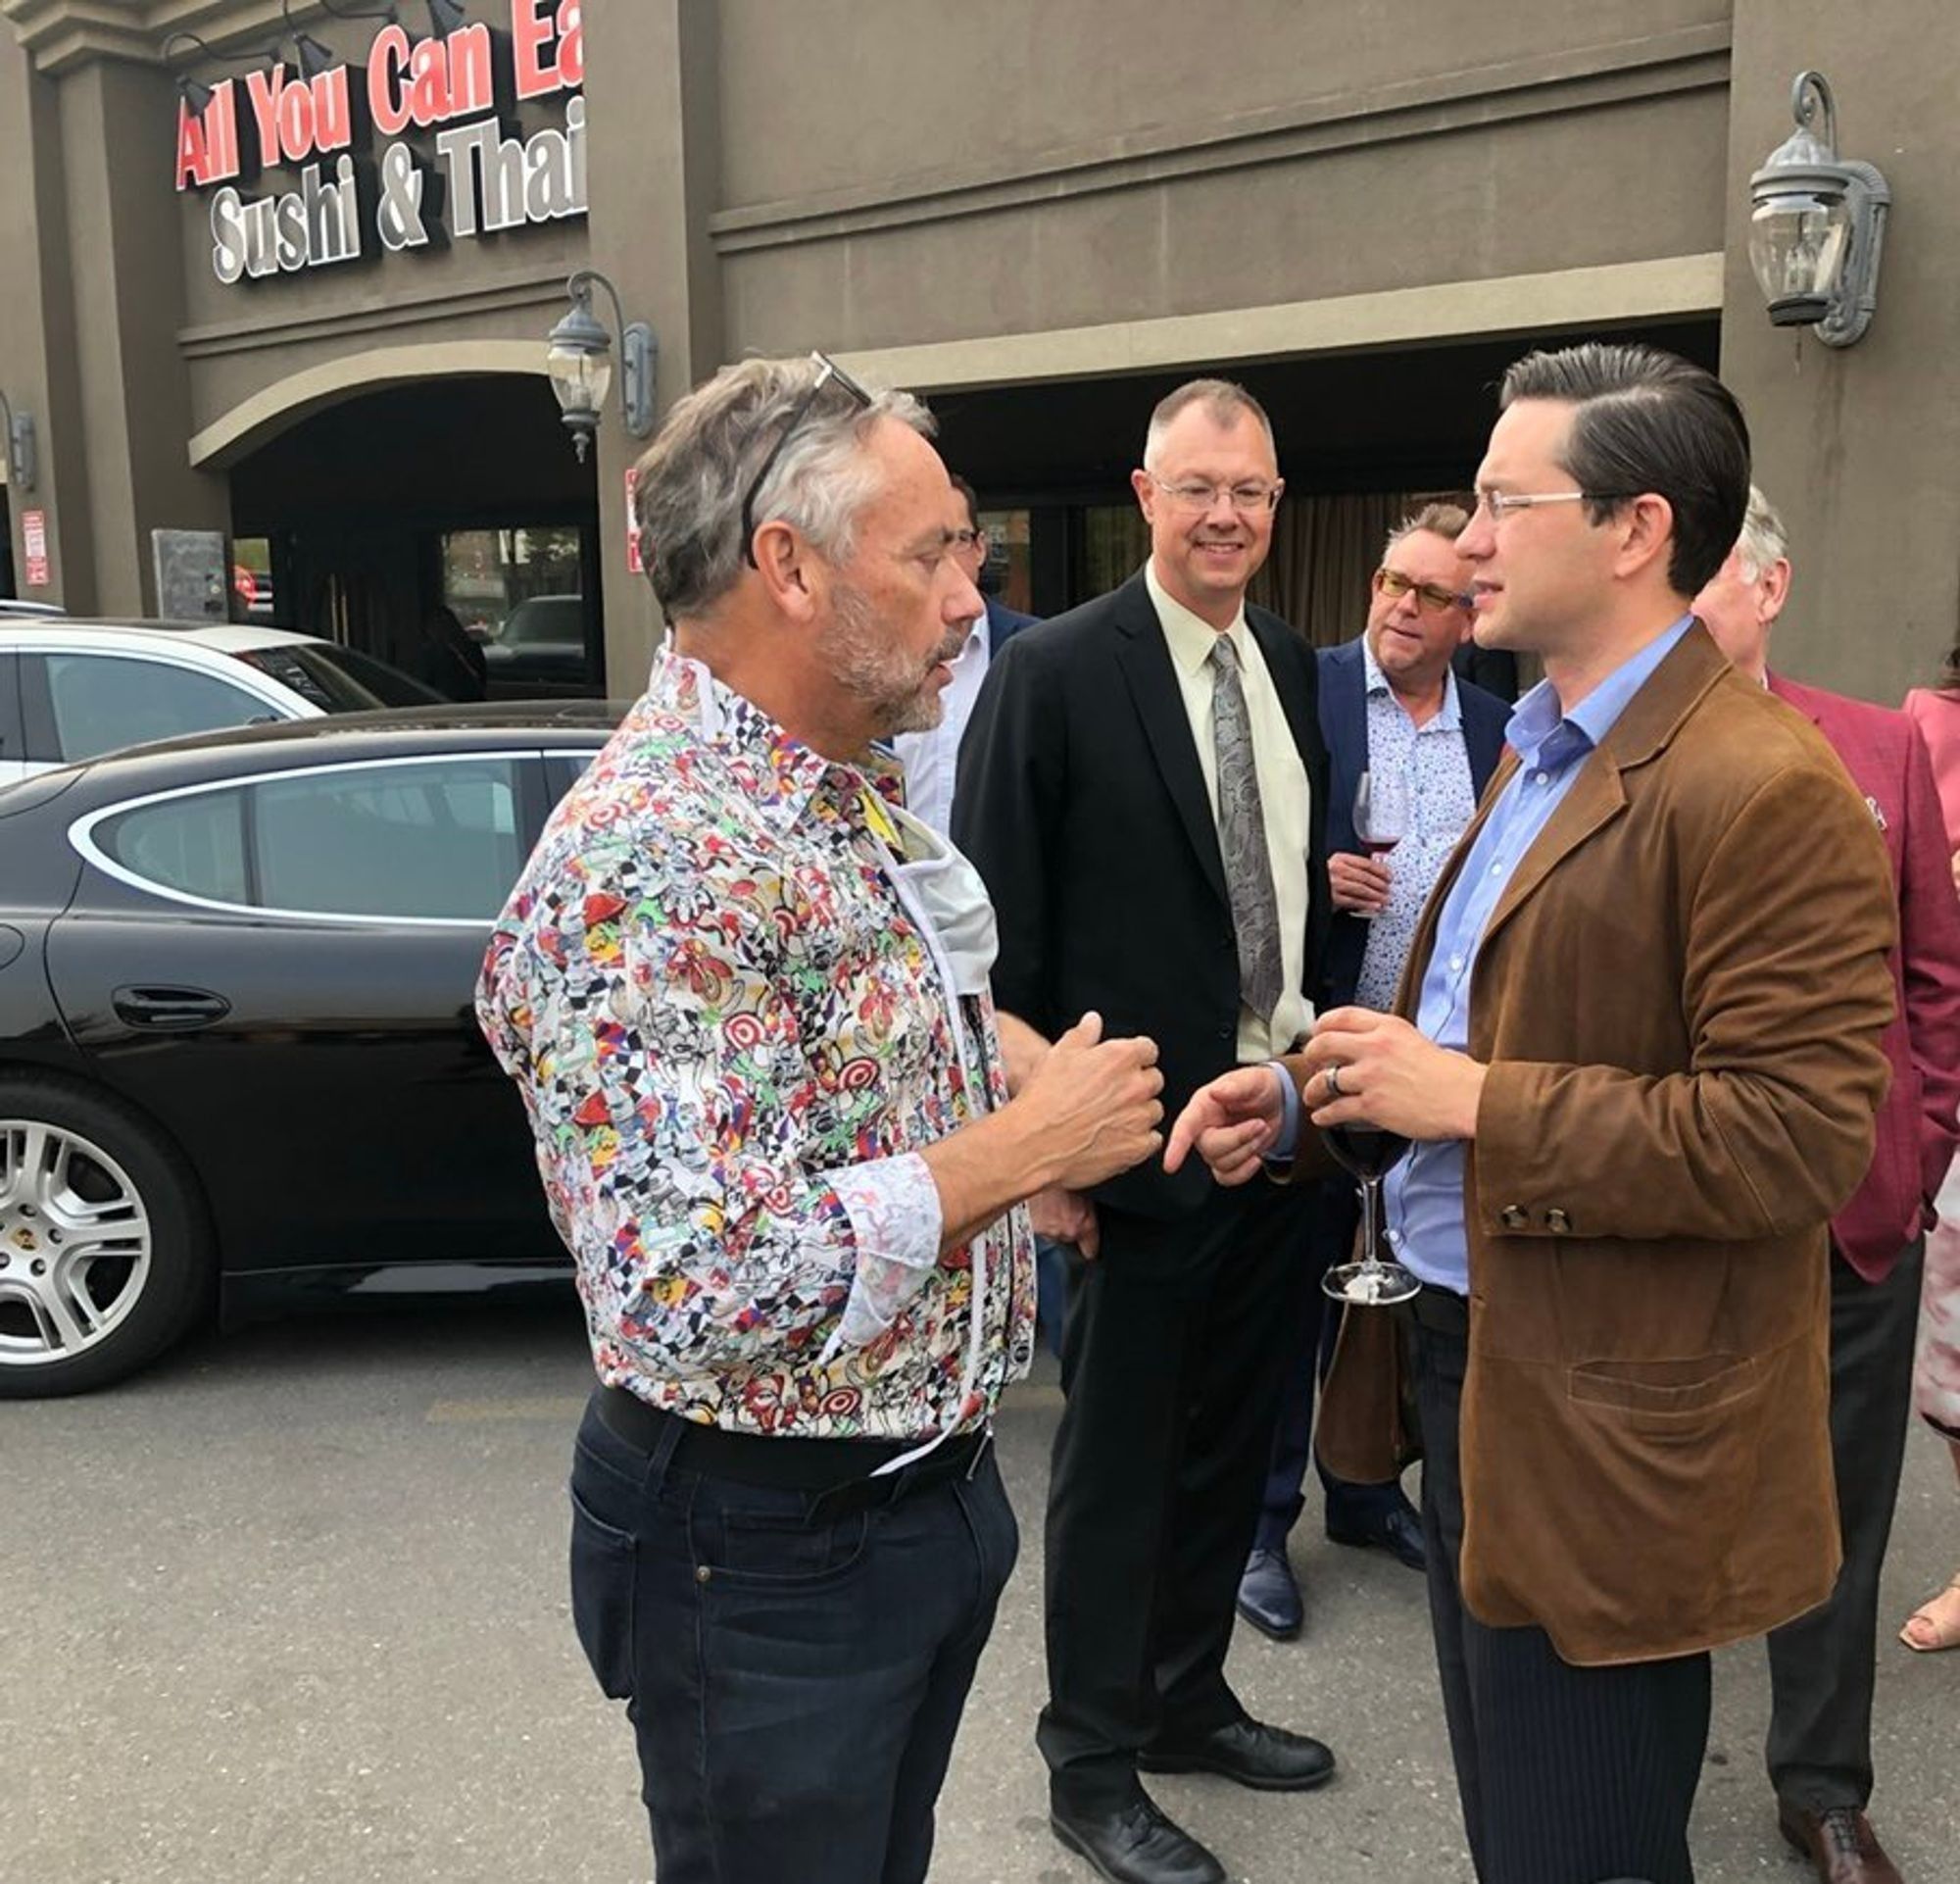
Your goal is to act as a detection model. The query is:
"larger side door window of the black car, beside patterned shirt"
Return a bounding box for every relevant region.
[251,759,523,921]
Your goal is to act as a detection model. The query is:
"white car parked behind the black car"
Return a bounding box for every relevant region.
[0,620,441,786]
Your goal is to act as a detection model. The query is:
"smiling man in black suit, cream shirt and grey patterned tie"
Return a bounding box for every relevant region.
[953,380,1333,1884]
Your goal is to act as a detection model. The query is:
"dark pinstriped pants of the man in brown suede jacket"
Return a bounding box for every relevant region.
[1413,1290,1709,1884]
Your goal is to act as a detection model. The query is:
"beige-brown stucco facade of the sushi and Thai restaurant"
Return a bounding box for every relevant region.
[0,0,1960,700]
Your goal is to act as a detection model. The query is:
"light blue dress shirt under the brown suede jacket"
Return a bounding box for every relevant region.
[1274,616,1693,1296]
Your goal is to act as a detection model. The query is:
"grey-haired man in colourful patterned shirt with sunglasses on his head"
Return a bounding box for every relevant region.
[478,359,1162,1884]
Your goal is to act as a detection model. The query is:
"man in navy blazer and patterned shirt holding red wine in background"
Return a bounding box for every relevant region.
[1239,504,1507,1641]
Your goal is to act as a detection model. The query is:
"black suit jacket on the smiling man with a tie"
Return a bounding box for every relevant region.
[953,572,1329,1217]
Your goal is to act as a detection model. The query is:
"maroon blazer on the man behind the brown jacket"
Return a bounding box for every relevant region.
[1770,674,1960,1282]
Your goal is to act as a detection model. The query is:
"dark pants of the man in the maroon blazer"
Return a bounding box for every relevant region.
[1768,1241,1925,1811]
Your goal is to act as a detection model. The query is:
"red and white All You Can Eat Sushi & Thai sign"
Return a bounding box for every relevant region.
[176,0,586,284]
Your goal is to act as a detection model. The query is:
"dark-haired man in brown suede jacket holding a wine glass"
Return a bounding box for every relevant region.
[1164,345,1895,1884]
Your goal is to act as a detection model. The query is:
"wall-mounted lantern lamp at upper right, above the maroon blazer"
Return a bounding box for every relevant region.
[1748,73,1891,347]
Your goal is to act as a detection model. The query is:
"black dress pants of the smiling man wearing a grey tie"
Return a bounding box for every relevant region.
[1035,1178,1315,1811]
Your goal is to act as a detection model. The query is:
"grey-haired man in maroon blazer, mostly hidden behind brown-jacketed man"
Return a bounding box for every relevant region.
[1695,486,1960,1884]
